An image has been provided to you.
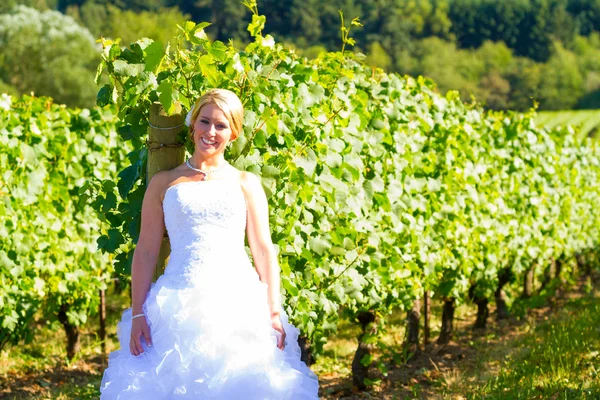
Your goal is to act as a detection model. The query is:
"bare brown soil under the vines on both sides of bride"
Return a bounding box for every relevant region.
[0,276,596,400]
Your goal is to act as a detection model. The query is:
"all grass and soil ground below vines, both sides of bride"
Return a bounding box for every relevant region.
[0,288,600,400]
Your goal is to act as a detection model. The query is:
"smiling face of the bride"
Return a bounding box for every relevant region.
[194,103,232,155]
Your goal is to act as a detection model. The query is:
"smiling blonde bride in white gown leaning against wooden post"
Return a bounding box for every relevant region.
[100,89,318,400]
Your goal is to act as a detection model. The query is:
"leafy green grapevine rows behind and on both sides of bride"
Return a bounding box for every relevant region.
[0,4,600,396]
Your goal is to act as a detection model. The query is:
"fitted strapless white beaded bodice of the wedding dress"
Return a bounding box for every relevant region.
[163,179,249,275]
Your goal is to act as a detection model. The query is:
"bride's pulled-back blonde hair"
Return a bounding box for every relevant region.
[190,89,244,141]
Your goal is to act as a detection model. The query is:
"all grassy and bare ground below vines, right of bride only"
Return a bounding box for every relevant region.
[313,287,600,399]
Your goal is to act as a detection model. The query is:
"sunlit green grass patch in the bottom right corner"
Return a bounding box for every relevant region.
[448,295,600,399]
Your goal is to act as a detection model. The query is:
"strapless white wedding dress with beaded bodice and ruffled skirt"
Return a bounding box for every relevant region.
[100,180,318,400]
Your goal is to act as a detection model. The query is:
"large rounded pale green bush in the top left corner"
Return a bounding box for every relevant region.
[0,6,100,106]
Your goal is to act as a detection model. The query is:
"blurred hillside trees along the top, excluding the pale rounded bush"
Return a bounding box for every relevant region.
[0,0,600,111]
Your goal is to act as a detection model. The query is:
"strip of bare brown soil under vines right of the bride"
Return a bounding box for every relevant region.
[319,280,598,400]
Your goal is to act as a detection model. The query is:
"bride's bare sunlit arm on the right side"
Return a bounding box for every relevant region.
[242,172,285,349]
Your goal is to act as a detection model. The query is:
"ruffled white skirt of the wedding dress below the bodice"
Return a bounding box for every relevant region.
[100,270,318,400]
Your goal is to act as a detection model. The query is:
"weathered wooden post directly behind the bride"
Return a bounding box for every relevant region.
[146,102,187,280]
